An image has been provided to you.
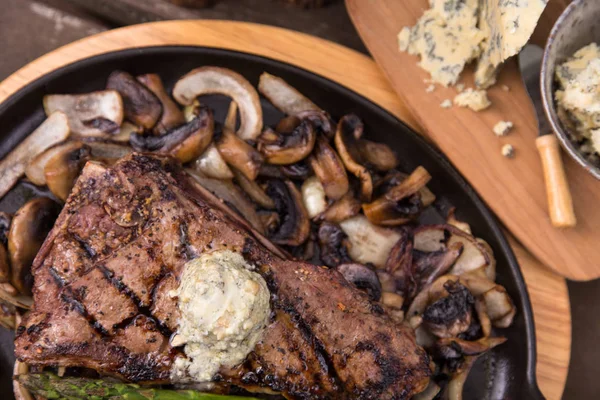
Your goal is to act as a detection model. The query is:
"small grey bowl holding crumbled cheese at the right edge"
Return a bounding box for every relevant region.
[540,0,600,179]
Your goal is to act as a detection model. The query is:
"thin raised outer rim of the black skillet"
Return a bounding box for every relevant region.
[0,45,544,399]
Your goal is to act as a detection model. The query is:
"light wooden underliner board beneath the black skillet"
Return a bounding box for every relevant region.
[0,21,571,399]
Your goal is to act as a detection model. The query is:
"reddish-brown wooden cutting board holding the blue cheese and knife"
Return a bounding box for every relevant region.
[346,0,600,280]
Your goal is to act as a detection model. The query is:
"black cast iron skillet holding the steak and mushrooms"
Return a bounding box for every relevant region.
[0,46,543,399]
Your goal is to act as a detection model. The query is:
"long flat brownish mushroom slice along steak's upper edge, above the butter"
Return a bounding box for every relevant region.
[186,168,265,234]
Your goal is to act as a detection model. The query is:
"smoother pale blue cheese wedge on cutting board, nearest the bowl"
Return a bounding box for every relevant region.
[475,0,548,88]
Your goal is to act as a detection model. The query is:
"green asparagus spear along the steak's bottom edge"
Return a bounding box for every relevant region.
[16,373,257,400]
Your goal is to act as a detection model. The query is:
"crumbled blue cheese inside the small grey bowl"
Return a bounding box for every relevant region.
[555,43,600,154]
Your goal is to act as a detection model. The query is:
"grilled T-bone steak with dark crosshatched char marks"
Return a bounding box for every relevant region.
[15,154,430,399]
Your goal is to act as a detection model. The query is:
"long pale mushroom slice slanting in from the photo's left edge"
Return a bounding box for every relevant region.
[0,111,71,198]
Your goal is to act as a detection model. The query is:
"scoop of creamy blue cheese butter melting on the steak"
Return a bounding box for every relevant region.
[170,250,271,383]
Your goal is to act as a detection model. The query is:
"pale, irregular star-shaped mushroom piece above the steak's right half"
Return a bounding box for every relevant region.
[340,214,400,268]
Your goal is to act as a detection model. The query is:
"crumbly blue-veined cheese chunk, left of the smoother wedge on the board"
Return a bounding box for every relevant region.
[398,0,484,86]
